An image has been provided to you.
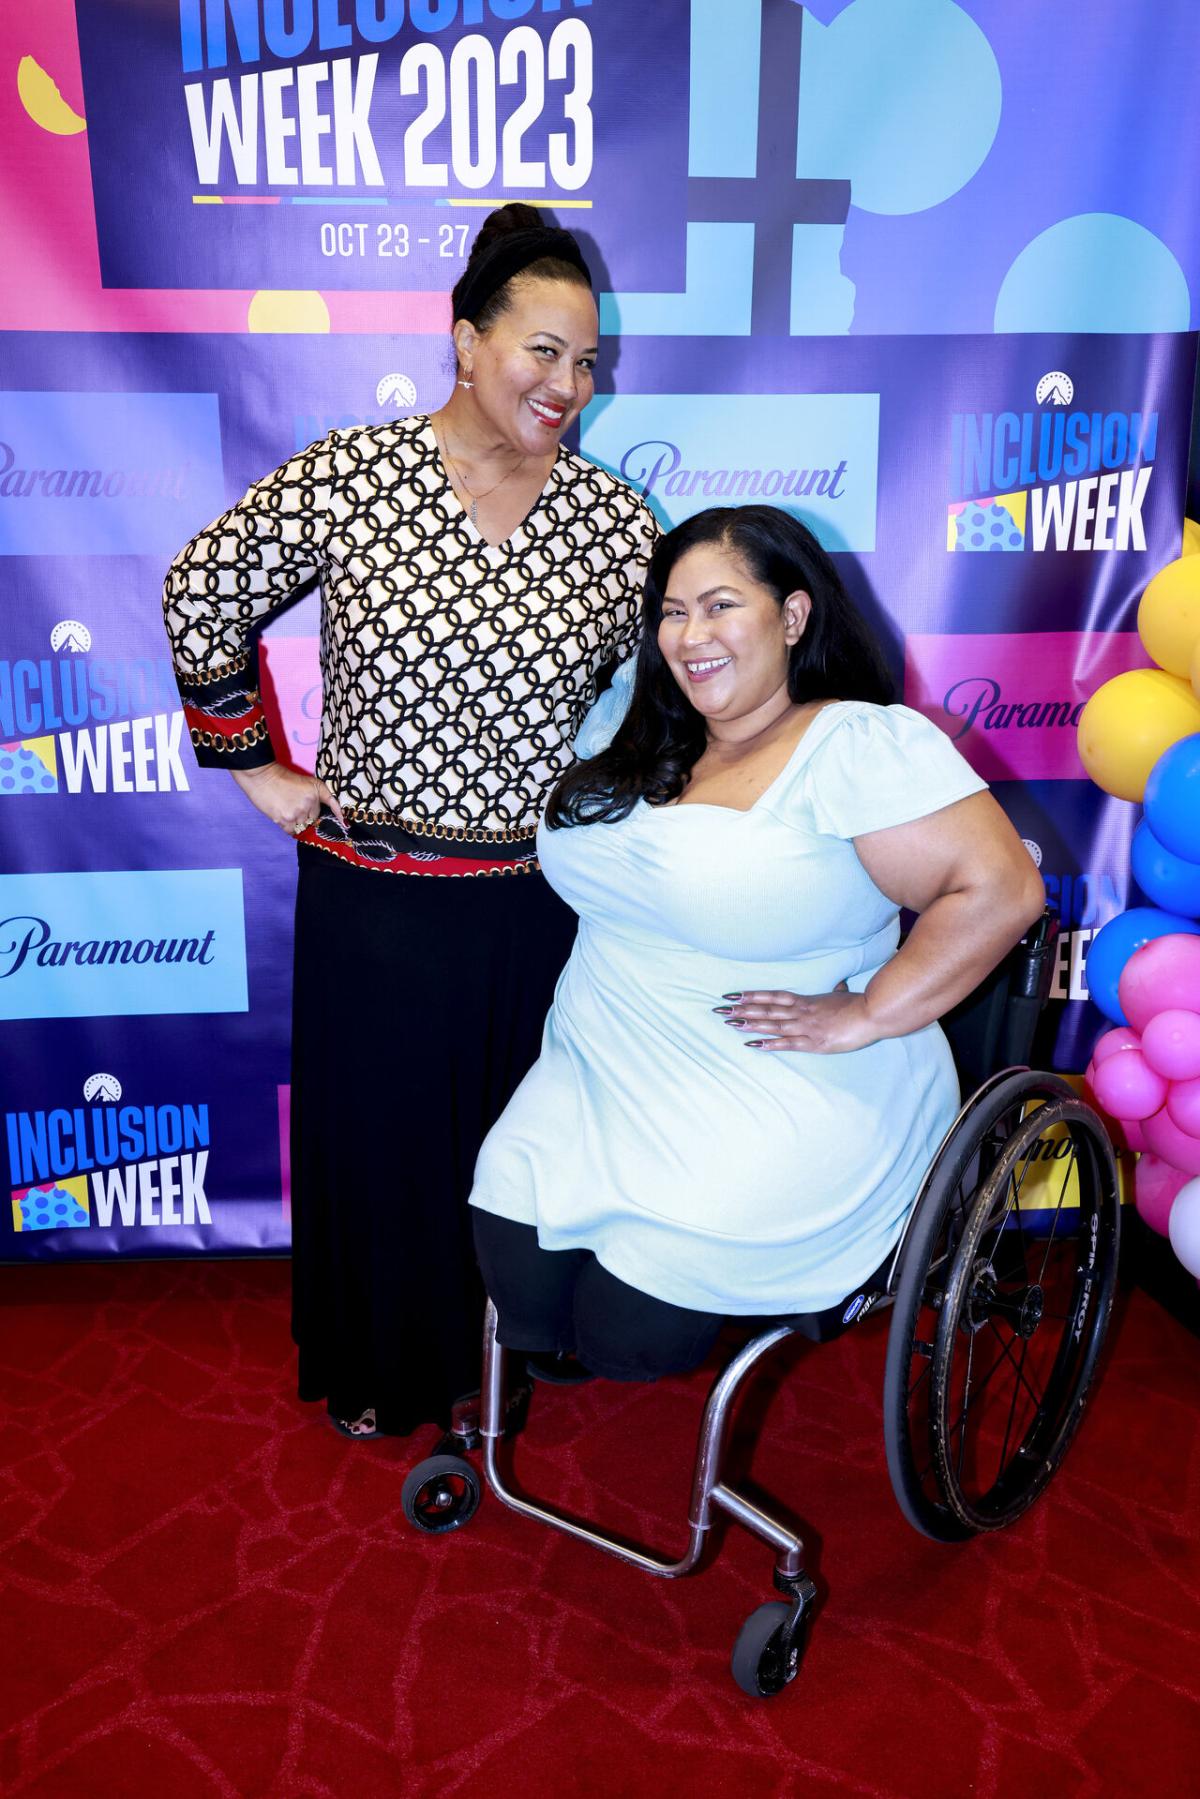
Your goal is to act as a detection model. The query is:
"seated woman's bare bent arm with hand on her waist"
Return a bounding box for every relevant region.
[729,793,1045,1054]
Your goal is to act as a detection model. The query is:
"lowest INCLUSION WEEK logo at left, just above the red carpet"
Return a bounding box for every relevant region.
[4,1074,212,1232]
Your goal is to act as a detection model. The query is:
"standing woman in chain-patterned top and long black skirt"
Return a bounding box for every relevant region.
[164,205,657,1437]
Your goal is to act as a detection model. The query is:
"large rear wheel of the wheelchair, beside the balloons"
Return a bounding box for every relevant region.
[883,1070,1121,1542]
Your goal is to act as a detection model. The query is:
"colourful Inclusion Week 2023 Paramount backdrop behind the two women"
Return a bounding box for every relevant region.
[0,0,1200,1259]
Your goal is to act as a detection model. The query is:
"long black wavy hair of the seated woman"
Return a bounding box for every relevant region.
[545,506,894,829]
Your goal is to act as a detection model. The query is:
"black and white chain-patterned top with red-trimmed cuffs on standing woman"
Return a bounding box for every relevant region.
[164,416,658,860]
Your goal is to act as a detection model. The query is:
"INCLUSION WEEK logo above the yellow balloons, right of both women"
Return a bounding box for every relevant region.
[946,369,1159,554]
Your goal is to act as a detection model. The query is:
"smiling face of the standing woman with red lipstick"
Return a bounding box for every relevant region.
[453,279,599,455]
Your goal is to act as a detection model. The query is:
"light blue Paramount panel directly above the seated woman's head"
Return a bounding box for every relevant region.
[579,394,880,550]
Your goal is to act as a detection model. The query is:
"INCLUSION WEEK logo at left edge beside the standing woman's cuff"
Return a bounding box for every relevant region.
[0,619,189,799]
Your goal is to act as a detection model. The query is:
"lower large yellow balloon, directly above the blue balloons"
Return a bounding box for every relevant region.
[1079,669,1200,801]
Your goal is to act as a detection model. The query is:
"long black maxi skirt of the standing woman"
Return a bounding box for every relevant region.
[291,846,576,1434]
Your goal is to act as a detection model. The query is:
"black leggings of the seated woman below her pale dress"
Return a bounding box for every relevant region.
[475,1209,891,1380]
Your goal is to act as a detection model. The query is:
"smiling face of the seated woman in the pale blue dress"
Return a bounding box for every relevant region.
[658,543,811,725]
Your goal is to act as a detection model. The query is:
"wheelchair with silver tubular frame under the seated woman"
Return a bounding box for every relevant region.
[401,912,1121,1698]
